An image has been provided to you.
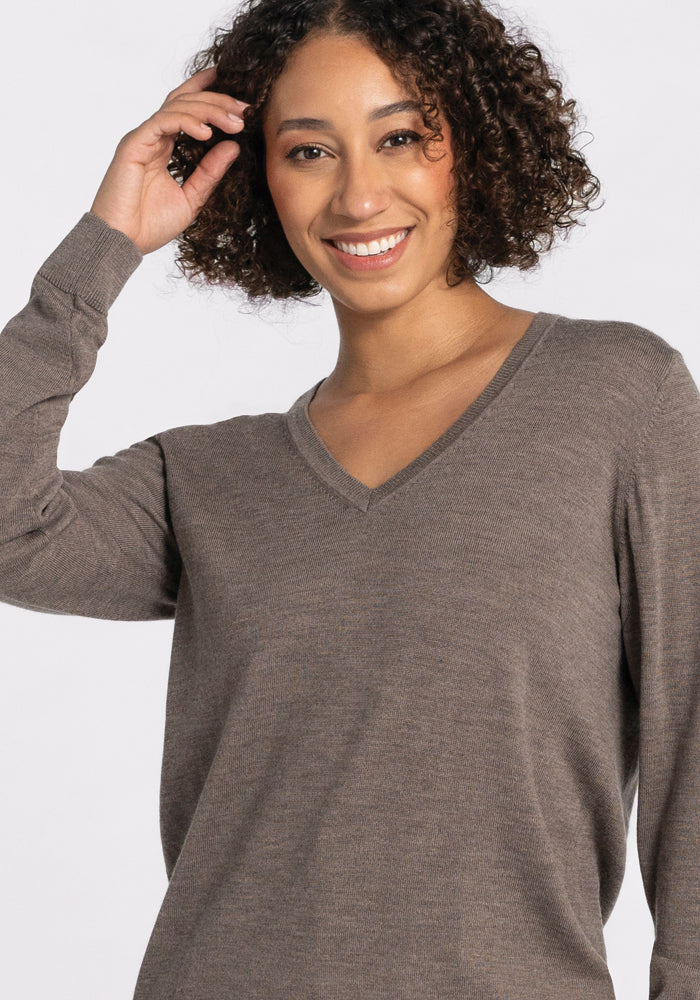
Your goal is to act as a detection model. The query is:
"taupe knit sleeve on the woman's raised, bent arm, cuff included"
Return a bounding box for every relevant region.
[0,212,181,621]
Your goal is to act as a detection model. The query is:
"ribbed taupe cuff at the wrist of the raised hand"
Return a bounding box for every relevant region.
[39,212,143,313]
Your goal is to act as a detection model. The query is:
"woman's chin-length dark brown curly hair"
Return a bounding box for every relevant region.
[168,0,600,301]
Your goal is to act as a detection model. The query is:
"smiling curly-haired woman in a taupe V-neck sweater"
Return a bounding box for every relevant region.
[0,0,700,1000]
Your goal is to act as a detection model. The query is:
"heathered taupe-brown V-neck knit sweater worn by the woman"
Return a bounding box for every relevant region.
[0,213,700,1000]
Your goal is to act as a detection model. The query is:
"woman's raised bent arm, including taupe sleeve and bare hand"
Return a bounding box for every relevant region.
[0,70,250,620]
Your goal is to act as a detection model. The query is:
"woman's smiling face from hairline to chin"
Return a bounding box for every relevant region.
[264,34,454,313]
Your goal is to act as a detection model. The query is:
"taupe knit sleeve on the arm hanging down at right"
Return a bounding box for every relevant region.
[620,350,700,1000]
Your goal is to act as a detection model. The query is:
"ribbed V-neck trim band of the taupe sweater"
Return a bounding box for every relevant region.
[284,312,559,512]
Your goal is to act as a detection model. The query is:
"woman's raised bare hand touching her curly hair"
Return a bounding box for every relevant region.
[90,66,248,254]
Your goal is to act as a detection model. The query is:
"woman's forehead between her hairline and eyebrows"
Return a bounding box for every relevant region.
[265,34,416,124]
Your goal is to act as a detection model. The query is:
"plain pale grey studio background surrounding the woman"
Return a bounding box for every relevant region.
[0,0,700,1000]
